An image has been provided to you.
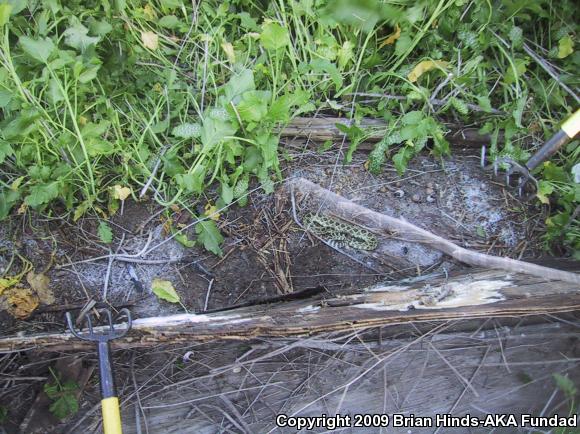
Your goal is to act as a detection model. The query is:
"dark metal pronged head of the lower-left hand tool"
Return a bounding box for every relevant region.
[65,308,132,342]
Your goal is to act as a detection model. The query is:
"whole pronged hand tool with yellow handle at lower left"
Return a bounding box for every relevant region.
[66,309,131,434]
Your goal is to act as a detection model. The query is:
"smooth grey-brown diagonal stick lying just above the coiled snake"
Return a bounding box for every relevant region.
[290,178,580,288]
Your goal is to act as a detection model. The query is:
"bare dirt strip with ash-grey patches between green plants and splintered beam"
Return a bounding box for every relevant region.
[0,144,543,334]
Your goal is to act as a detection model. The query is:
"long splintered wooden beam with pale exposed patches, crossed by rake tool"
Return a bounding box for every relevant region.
[0,270,580,352]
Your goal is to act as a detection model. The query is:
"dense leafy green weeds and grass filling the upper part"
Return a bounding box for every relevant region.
[0,0,580,254]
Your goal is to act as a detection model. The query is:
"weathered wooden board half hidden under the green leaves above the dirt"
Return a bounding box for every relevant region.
[280,117,503,150]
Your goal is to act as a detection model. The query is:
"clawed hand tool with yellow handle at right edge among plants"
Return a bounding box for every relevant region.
[482,109,580,197]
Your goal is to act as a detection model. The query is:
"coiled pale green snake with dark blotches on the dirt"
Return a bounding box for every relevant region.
[303,213,378,250]
